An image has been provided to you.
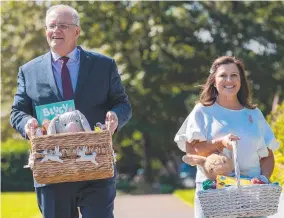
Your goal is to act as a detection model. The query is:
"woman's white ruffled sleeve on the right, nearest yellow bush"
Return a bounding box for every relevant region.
[258,111,280,158]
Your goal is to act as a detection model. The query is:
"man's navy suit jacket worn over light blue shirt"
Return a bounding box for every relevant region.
[10,46,132,187]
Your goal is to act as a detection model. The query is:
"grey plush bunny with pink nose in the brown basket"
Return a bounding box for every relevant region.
[47,110,91,135]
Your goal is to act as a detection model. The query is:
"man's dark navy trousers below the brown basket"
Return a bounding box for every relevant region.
[36,178,116,218]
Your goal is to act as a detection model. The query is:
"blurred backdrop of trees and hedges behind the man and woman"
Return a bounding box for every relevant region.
[1,0,284,217]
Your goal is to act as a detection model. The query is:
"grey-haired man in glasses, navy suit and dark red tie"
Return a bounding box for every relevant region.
[11,5,131,218]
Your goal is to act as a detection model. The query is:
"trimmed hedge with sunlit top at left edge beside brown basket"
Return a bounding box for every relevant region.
[1,139,34,191]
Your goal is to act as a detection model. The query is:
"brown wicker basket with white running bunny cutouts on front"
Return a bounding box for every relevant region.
[31,131,115,184]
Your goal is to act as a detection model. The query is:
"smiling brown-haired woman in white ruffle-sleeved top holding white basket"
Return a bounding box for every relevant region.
[175,56,279,218]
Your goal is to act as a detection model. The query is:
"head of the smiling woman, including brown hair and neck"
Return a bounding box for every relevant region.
[200,56,256,109]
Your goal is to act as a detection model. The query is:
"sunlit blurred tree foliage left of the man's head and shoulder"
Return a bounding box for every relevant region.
[1,1,48,141]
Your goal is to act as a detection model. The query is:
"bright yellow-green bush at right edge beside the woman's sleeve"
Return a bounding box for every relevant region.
[267,101,284,185]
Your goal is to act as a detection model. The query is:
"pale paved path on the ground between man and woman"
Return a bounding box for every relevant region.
[114,195,194,218]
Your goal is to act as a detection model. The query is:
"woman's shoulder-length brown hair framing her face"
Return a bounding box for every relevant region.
[199,56,256,109]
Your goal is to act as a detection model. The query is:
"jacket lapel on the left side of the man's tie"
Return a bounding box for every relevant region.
[42,52,63,100]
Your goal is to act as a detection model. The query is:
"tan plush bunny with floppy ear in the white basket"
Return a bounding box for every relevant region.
[182,154,234,180]
